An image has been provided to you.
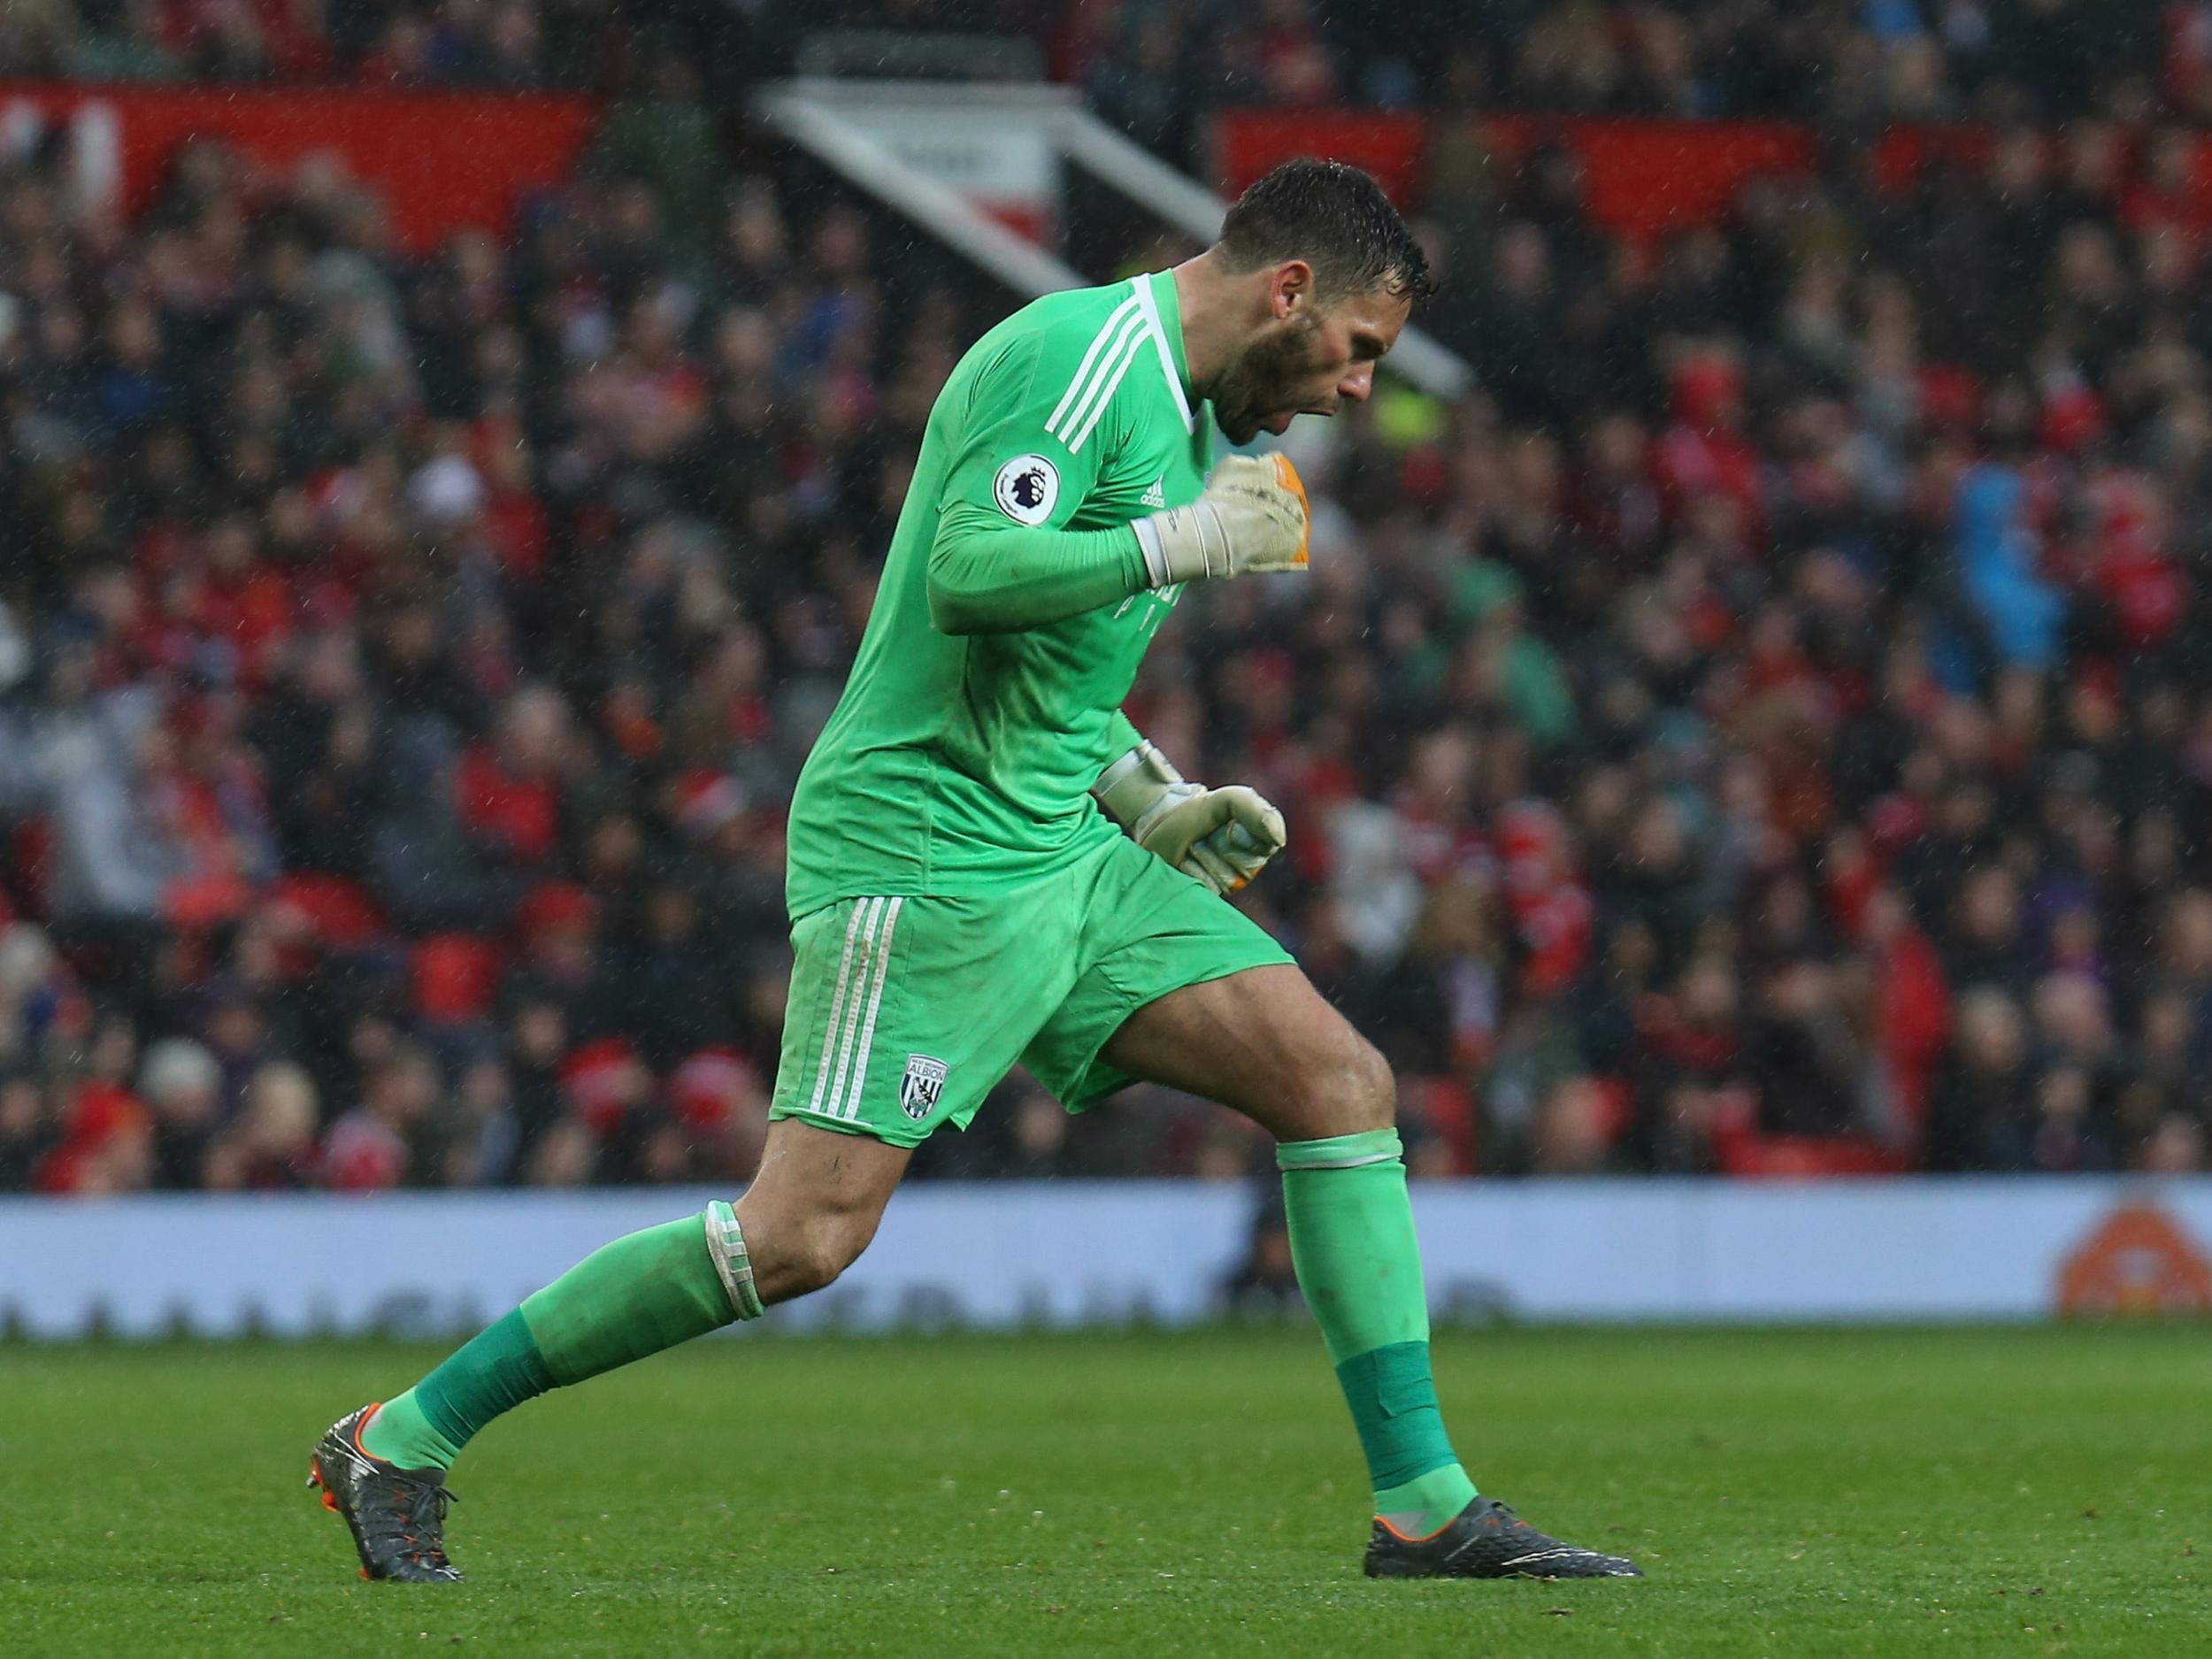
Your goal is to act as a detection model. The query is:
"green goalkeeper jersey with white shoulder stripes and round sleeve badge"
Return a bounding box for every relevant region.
[786,273,1212,918]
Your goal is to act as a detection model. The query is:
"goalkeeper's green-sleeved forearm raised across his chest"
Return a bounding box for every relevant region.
[929,513,1150,633]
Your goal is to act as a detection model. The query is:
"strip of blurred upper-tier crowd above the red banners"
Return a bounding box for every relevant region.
[0,0,2212,134]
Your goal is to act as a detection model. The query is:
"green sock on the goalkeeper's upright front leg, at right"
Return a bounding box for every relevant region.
[1274,1128,1476,1538]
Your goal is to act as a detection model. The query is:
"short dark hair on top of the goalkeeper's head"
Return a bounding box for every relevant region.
[1221,157,1436,299]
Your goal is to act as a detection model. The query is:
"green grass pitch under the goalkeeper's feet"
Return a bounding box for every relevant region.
[0,1327,2212,1659]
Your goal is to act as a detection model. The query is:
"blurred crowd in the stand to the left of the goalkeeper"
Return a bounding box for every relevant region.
[0,119,1057,1190]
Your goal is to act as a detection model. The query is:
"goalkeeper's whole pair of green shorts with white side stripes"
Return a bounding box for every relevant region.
[768,836,1292,1146]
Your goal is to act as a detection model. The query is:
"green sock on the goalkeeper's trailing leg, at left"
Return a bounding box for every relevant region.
[361,1203,764,1469]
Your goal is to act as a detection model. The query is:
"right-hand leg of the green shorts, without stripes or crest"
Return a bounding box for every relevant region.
[1022,841,1292,1110]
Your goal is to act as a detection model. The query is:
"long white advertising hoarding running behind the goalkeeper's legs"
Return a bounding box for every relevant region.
[0,1177,2212,1340]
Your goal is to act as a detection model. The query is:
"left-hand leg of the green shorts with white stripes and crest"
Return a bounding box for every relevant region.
[768,880,1082,1148]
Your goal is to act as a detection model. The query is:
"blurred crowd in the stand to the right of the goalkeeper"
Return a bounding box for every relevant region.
[1283,122,2212,1171]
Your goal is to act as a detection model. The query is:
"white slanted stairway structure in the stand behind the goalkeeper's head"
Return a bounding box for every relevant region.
[755,75,1476,401]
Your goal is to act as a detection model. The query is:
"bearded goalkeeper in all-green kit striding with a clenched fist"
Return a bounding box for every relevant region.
[314,162,1635,1579]
